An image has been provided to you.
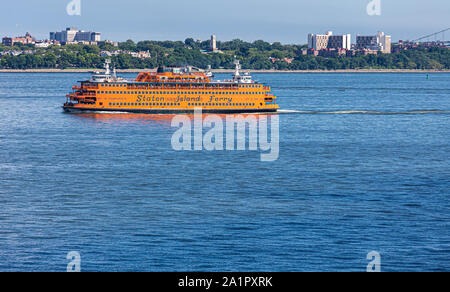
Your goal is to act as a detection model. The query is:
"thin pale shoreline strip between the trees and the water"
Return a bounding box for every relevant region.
[0,69,450,74]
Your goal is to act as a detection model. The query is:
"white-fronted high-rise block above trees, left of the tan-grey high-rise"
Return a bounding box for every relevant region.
[308,31,352,51]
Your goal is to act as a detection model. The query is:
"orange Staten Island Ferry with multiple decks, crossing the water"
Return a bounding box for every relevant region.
[63,60,279,114]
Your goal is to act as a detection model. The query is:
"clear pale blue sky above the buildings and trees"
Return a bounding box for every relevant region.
[0,0,450,44]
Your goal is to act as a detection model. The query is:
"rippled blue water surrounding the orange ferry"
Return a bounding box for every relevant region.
[0,74,450,271]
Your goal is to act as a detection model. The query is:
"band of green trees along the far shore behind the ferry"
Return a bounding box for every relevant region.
[0,39,450,73]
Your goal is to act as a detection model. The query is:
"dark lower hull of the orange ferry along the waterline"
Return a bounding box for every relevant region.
[63,106,277,114]
